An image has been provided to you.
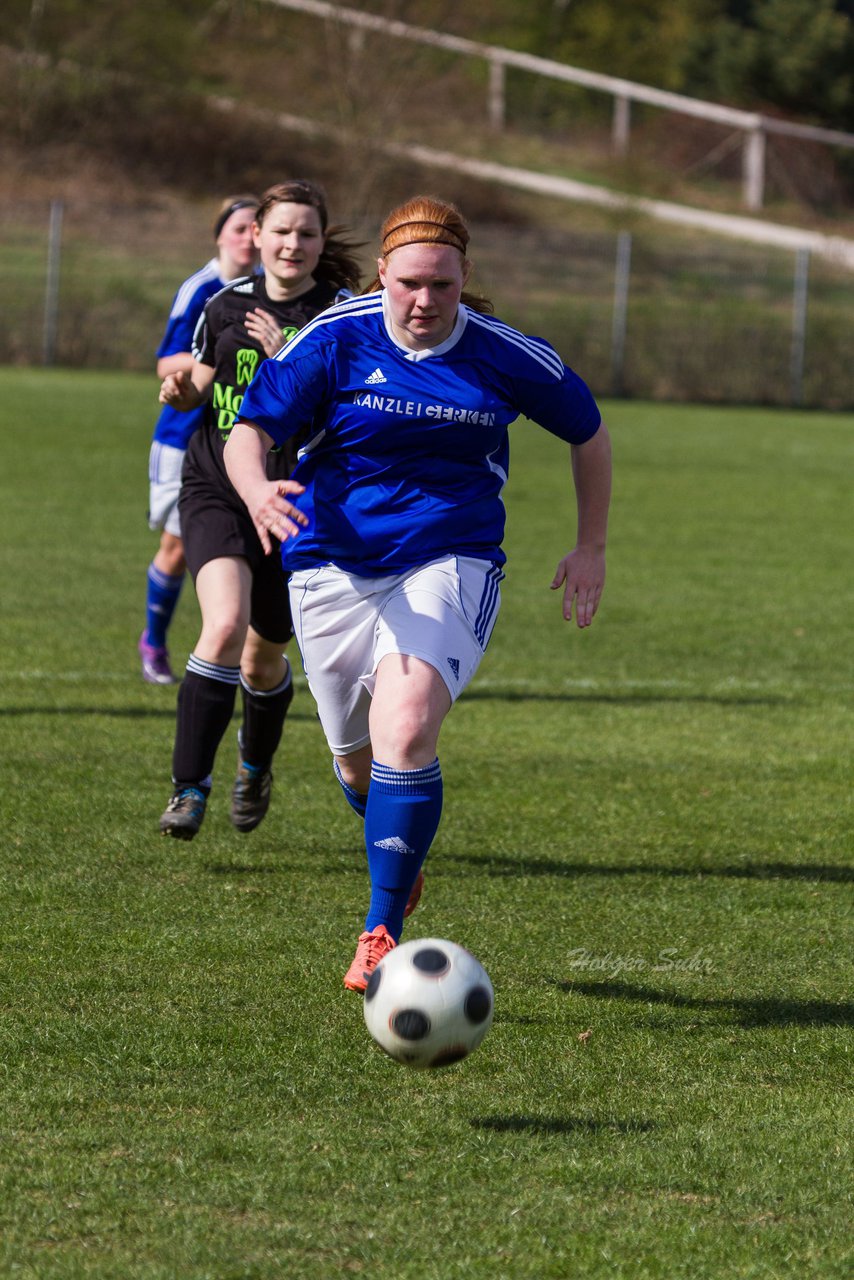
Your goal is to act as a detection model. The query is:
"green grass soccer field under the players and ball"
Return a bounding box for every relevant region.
[0,370,854,1280]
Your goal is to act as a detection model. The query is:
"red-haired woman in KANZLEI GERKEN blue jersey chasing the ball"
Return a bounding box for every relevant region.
[225,197,611,991]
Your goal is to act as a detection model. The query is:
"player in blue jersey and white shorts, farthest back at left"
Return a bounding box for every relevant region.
[138,196,259,685]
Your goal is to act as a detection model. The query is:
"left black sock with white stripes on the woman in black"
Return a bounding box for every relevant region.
[172,654,239,791]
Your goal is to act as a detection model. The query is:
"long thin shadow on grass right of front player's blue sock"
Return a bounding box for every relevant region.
[442,854,854,884]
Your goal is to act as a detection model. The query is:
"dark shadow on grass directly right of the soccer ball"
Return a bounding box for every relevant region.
[557,982,854,1029]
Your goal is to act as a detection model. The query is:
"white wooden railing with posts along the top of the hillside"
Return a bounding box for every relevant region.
[268,0,854,210]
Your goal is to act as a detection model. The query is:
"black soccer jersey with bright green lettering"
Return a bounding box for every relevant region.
[184,274,335,489]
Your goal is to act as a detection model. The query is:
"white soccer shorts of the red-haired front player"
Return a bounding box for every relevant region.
[291,556,504,755]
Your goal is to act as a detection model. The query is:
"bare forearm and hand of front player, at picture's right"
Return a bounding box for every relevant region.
[552,422,611,627]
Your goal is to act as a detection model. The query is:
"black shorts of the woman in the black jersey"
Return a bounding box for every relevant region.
[178,479,293,645]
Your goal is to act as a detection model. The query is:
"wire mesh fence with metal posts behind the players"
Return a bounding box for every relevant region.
[0,197,854,410]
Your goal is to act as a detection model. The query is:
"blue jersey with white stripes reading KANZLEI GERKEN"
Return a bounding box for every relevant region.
[239,292,600,577]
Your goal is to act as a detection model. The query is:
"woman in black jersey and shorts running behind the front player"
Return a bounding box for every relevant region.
[160,180,359,840]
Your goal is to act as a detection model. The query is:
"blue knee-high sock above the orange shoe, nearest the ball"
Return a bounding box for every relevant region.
[365,759,442,941]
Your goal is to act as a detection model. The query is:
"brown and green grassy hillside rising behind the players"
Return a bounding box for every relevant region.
[0,4,854,410]
